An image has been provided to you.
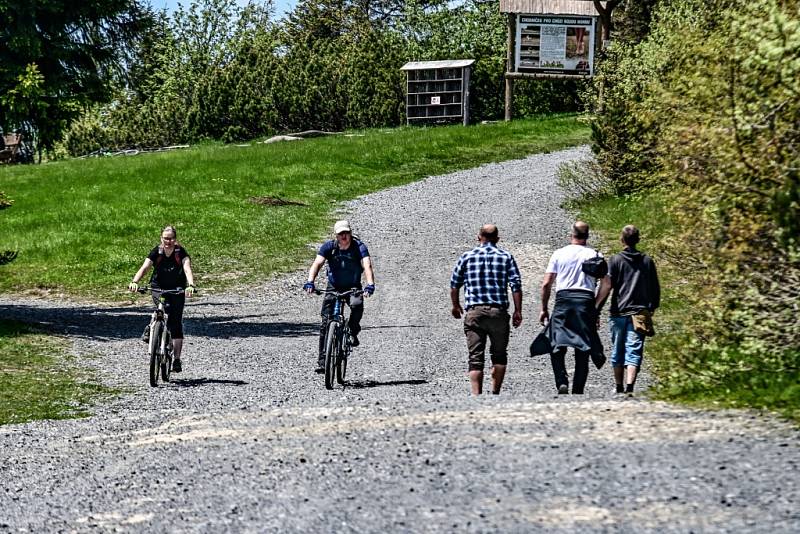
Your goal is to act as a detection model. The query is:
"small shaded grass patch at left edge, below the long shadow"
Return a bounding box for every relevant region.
[0,321,112,425]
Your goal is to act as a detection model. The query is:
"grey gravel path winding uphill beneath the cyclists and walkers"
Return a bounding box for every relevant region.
[0,148,800,532]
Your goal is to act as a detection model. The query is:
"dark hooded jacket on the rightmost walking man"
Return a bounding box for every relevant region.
[608,248,661,316]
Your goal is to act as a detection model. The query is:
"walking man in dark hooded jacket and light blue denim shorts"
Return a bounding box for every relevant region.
[597,224,661,396]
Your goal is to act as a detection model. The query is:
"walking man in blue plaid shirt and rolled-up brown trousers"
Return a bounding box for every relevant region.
[450,224,522,395]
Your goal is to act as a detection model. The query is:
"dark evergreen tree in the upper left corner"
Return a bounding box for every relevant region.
[0,0,153,154]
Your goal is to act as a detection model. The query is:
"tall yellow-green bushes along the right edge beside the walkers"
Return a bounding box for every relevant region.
[593,0,800,416]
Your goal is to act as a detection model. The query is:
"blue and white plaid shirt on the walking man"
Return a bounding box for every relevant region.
[450,243,522,309]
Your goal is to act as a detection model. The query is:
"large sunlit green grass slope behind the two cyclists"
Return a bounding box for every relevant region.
[0,115,589,300]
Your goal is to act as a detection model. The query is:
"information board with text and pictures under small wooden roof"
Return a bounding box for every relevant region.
[514,15,596,75]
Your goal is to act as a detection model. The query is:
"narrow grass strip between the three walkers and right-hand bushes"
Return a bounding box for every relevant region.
[578,192,800,422]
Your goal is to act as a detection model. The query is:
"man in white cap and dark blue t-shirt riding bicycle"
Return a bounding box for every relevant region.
[303,221,375,373]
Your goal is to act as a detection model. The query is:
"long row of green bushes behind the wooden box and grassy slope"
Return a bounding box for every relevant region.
[64,0,582,155]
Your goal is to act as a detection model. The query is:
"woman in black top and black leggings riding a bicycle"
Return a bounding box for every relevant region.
[128,226,194,373]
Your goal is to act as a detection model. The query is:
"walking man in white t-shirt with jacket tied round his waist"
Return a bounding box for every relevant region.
[539,221,604,394]
